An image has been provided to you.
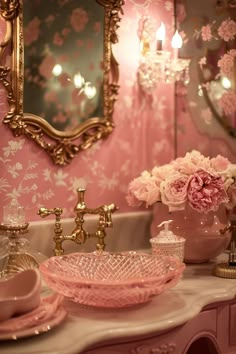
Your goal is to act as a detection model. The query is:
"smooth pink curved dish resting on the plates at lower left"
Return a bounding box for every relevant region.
[0,269,41,322]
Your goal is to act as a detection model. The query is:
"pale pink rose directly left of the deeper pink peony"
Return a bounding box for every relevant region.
[160,174,189,211]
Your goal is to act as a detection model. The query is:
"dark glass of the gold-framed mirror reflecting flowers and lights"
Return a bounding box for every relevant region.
[23,0,104,131]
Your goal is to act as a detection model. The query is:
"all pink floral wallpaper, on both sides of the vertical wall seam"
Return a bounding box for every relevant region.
[0,0,236,221]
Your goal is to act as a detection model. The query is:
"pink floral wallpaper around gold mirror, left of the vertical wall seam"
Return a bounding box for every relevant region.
[0,0,174,220]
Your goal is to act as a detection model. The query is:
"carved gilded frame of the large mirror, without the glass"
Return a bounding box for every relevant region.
[0,0,124,165]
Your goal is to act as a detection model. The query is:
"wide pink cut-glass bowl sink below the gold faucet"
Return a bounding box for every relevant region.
[40,252,185,308]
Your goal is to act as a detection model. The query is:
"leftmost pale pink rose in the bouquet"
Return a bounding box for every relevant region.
[126,171,160,206]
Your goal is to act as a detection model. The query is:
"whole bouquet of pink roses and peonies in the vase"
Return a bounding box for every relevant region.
[126,150,236,213]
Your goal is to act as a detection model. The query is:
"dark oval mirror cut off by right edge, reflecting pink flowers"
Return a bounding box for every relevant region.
[199,6,236,137]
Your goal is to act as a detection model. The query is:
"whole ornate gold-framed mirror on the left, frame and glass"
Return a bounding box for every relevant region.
[0,0,124,165]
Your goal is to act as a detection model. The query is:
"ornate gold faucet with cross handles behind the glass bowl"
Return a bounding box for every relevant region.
[38,188,118,256]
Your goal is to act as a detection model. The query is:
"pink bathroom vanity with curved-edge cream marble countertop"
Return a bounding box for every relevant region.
[0,253,236,354]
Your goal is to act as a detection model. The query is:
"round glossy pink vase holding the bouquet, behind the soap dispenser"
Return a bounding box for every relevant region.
[151,204,231,263]
